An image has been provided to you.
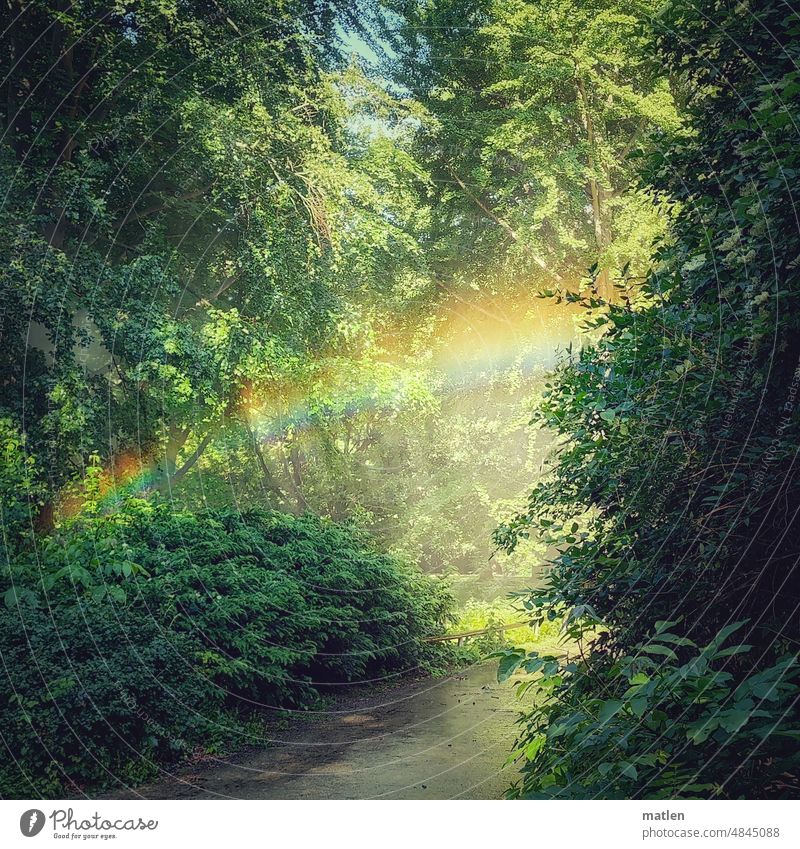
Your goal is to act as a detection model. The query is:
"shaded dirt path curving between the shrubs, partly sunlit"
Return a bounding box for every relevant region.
[122,663,519,799]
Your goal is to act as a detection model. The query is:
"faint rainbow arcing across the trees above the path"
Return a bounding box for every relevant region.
[65,291,580,516]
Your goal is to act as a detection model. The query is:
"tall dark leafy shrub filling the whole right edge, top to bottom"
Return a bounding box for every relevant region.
[496,0,800,796]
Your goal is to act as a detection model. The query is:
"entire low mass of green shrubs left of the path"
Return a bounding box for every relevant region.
[0,501,450,796]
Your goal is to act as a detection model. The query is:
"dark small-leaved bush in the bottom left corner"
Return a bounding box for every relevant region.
[0,599,222,798]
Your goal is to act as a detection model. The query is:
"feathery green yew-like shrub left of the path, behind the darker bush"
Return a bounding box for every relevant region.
[128,510,448,704]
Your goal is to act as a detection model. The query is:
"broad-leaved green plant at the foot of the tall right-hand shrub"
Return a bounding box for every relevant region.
[500,622,800,799]
